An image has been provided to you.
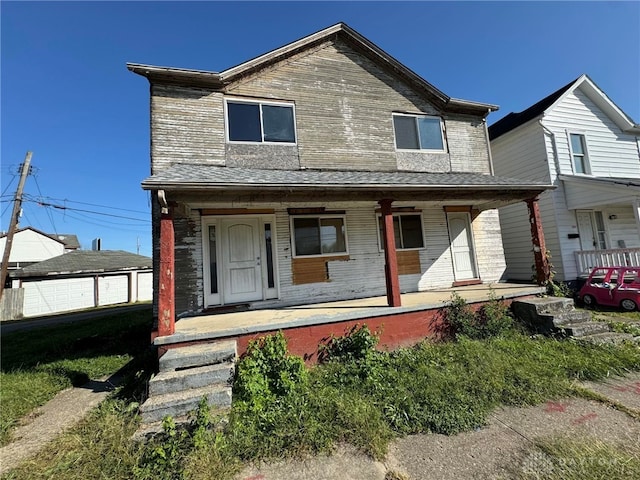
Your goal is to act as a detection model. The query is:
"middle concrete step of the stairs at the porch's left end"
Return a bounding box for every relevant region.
[149,362,234,397]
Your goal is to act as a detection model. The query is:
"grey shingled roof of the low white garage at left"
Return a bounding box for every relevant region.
[10,250,153,278]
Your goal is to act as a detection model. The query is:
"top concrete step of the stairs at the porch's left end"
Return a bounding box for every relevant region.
[159,340,236,372]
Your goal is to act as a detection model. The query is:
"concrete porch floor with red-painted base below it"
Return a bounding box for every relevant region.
[154,283,544,361]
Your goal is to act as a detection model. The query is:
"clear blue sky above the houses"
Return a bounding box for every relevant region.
[0,1,640,255]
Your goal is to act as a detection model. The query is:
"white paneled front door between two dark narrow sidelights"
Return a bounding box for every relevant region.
[220,217,263,303]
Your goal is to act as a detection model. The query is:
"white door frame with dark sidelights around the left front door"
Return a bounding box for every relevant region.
[201,214,280,308]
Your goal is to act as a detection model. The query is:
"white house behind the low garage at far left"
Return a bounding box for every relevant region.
[0,227,80,270]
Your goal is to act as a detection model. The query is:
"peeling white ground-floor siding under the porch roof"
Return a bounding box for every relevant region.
[176,198,504,313]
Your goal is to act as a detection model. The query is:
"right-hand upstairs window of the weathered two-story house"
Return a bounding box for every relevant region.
[393,113,444,152]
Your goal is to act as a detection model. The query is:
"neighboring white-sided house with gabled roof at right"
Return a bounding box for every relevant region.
[489,75,640,281]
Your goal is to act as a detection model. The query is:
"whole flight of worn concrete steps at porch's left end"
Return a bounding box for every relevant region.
[140,340,237,424]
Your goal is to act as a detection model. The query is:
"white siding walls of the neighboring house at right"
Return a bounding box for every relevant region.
[491,84,640,280]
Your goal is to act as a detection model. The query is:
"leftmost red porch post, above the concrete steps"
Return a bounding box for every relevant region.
[158,191,176,337]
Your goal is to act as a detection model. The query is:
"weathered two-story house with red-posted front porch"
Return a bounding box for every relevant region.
[128,23,548,421]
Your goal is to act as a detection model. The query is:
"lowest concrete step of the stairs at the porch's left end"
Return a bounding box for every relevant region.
[140,385,231,423]
